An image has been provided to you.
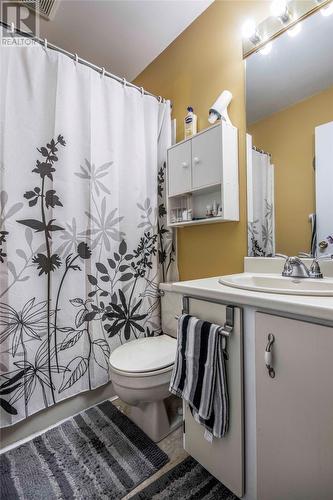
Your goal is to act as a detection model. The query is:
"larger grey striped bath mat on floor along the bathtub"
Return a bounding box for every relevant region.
[0,401,169,500]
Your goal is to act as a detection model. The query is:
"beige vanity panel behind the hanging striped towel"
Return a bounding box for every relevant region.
[184,299,244,497]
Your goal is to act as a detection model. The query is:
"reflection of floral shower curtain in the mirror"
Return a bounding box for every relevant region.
[248,150,275,257]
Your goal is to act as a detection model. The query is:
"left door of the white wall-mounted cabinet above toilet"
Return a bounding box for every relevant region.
[168,141,191,196]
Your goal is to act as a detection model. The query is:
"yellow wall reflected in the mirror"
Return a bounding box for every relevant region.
[249,87,333,255]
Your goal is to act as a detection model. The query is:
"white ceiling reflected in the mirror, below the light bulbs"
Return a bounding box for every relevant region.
[246,12,333,124]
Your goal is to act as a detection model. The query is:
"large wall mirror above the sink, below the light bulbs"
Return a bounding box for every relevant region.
[245,11,333,256]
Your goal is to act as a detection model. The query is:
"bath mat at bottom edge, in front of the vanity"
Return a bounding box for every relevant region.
[131,457,239,500]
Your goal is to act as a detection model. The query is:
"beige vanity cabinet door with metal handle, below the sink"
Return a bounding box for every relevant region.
[255,313,333,500]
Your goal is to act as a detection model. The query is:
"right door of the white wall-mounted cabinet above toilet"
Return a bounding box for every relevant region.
[192,126,222,189]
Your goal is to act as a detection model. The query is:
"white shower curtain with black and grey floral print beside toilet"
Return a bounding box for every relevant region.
[0,45,176,427]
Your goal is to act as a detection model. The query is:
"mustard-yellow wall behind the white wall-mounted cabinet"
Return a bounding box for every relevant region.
[135,0,270,279]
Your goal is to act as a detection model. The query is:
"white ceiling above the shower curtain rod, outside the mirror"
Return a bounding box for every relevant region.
[29,0,213,81]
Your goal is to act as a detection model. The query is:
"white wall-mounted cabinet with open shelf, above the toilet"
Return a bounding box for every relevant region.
[167,122,239,226]
